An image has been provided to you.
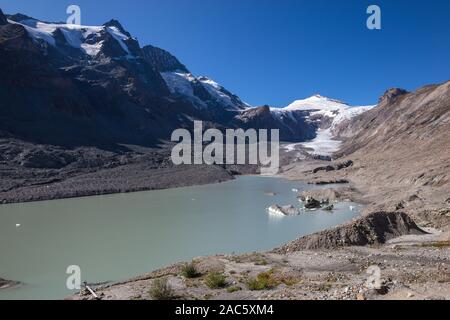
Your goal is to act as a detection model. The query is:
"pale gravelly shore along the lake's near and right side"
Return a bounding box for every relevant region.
[68,154,450,300]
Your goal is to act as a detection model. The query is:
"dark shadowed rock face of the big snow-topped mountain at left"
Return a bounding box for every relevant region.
[0,15,188,147]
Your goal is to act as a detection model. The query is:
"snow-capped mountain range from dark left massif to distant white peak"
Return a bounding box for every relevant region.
[0,10,370,146]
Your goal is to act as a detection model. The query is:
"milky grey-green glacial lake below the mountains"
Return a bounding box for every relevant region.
[0,176,361,299]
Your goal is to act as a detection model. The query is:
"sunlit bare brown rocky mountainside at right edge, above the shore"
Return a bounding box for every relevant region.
[328,81,450,227]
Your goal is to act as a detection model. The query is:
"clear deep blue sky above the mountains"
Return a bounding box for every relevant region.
[0,0,450,106]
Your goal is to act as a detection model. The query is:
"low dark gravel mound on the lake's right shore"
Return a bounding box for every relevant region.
[275,212,425,253]
